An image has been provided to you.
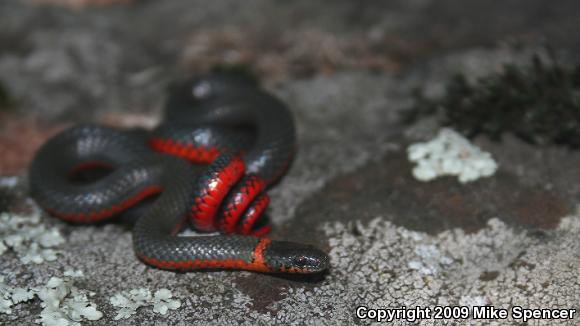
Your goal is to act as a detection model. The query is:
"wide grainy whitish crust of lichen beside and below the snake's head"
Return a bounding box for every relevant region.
[174,217,580,325]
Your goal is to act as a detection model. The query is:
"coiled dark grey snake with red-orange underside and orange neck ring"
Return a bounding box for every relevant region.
[29,74,329,274]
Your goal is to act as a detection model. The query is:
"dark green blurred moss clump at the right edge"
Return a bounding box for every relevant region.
[404,56,580,148]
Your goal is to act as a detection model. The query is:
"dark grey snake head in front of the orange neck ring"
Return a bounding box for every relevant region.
[264,241,329,274]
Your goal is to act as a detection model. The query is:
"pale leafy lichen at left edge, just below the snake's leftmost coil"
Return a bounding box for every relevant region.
[0,211,64,264]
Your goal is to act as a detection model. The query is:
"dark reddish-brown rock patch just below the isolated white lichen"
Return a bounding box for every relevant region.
[292,152,572,239]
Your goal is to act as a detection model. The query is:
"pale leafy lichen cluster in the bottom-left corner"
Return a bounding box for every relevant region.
[0,271,103,326]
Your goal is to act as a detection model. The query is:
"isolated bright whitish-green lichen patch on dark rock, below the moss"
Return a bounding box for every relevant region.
[407,128,497,183]
